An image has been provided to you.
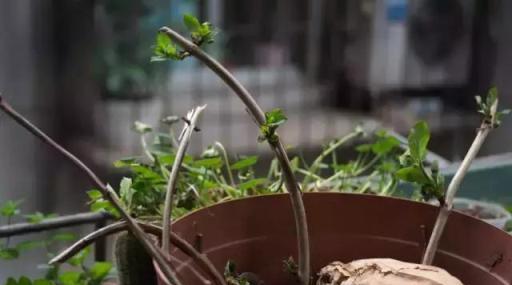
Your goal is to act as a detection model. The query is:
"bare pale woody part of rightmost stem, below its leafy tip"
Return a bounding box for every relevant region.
[421,123,492,265]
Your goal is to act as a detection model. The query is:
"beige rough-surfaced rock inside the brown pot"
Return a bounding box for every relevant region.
[316,258,463,285]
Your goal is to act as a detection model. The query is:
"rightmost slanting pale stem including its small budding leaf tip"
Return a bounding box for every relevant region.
[422,87,509,265]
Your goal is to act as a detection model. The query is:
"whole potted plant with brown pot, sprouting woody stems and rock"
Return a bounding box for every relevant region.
[0,16,512,284]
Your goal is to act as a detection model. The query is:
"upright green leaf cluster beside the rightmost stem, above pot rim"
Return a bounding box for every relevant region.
[395,121,444,204]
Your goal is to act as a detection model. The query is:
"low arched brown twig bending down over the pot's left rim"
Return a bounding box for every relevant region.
[50,221,226,285]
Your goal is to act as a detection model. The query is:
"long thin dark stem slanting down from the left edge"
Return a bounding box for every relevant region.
[0,96,181,285]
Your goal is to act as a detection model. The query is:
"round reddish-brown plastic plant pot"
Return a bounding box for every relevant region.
[153,193,512,285]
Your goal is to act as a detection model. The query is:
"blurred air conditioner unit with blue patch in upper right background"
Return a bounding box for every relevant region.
[368,0,475,93]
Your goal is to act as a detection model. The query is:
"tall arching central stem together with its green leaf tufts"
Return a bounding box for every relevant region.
[155,15,311,285]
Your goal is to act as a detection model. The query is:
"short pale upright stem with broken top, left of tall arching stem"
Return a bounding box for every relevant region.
[162,105,206,254]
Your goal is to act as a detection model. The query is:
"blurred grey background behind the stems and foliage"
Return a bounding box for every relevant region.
[0,0,512,276]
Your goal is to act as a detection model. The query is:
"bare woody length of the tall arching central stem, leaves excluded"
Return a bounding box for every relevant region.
[160,27,311,285]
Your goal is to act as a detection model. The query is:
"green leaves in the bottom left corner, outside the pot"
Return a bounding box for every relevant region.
[0,201,112,285]
